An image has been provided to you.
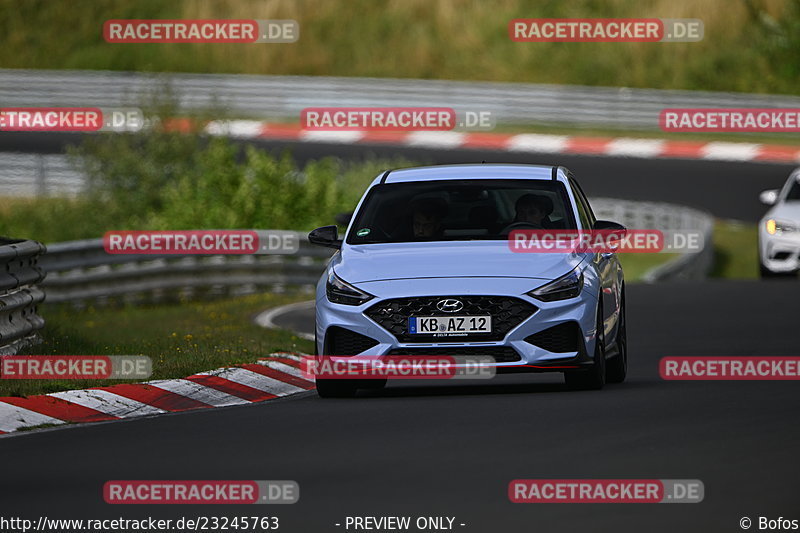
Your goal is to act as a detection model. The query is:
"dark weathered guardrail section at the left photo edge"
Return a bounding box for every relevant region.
[0,237,45,355]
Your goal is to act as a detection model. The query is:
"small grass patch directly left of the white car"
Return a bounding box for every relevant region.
[711,220,759,279]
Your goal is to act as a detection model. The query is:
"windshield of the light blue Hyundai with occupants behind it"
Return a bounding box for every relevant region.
[347,180,576,244]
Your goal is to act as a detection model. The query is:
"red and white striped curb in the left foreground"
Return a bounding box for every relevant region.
[0,352,314,433]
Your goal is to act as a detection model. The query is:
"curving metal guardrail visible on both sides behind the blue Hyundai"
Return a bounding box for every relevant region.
[40,198,713,306]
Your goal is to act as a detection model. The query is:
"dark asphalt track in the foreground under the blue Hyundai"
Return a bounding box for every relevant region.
[0,281,800,533]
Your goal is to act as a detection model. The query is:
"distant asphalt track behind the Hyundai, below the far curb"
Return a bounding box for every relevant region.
[0,133,796,222]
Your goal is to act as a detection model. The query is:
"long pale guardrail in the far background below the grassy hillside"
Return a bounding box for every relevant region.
[0,69,800,130]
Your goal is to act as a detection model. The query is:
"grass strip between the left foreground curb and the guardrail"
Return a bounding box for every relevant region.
[0,293,313,396]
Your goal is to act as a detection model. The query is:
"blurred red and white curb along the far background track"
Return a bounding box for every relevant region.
[204,120,800,163]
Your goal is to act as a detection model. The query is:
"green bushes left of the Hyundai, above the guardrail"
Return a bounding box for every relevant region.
[0,121,409,242]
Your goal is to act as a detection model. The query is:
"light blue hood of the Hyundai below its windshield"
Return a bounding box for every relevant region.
[332,241,584,283]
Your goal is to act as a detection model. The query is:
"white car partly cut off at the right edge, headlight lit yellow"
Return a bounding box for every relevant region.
[758,168,800,278]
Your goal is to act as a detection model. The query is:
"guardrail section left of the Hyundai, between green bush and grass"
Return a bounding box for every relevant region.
[41,232,332,307]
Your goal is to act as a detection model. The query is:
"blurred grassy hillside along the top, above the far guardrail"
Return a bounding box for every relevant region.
[0,0,800,94]
